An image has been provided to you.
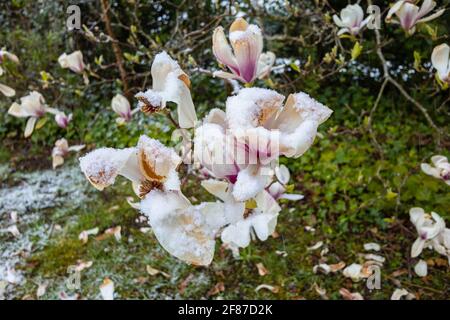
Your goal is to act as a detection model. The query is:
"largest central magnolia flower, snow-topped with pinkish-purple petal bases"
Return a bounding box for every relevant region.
[194,88,332,201]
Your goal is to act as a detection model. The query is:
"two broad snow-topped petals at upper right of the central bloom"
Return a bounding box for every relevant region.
[226,88,333,158]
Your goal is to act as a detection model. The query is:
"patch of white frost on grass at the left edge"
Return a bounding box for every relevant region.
[0,166,89,298]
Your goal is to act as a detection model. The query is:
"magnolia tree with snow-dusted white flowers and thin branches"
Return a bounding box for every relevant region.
[0,0,450,268]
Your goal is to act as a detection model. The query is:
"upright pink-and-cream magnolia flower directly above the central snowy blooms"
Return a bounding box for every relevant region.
[213,18,275,83]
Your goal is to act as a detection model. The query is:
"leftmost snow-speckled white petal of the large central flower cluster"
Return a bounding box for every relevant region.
[79,148,143,190]
